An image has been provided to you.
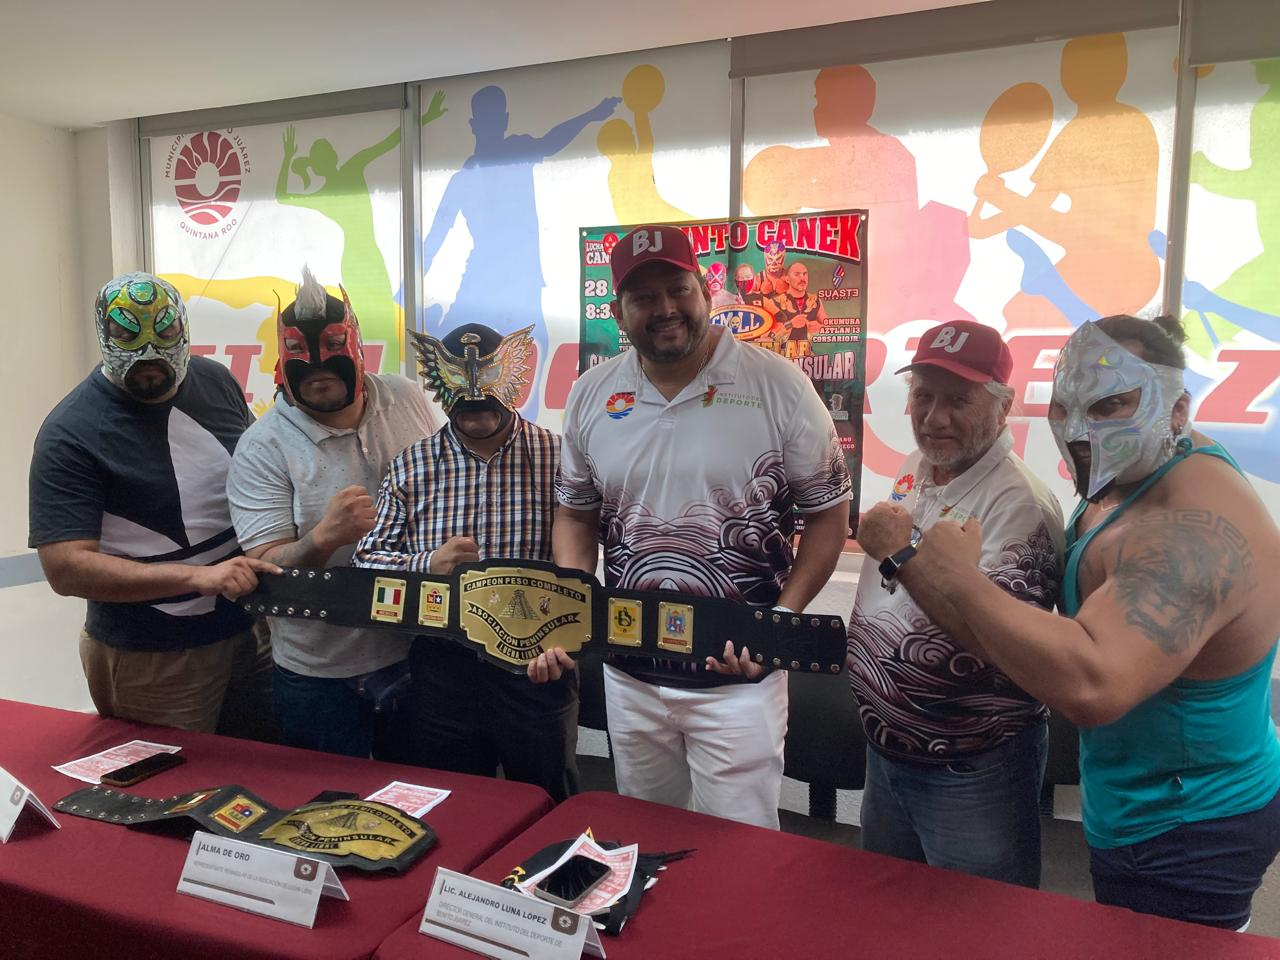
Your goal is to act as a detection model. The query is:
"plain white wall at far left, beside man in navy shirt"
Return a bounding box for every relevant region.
[0,115,126,709]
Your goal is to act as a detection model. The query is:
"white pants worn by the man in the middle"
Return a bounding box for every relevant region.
[604,664,787,829]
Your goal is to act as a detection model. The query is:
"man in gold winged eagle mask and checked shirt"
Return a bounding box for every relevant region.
[356,324,577,800]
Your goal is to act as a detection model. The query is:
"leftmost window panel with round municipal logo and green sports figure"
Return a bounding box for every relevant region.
[151,104,445,413]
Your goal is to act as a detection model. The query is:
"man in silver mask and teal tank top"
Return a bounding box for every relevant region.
[915,316,1280,929]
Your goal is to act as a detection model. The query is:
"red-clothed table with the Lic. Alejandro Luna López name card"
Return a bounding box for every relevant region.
[375,794,1280,960]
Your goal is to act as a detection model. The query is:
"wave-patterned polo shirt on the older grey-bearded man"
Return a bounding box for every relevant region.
[849,428,1064,763]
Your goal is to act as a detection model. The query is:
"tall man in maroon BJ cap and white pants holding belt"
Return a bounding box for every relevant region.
[529,227,850,828]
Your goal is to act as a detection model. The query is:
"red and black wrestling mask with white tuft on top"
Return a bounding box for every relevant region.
[275,266,365,413]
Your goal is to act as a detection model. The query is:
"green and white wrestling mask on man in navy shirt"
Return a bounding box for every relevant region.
[95,273,191,401]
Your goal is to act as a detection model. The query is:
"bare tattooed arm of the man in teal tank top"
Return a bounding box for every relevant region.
[916,511,1257,726]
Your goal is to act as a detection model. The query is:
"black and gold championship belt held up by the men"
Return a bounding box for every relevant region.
[239,559,846,673]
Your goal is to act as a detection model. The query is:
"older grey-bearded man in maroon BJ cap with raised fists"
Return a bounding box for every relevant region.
[849,320,1062,887]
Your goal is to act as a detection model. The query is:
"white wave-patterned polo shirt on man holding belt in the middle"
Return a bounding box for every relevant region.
[557,334,850,686]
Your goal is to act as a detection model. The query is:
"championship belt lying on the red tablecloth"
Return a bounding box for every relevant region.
[54,786,435,873]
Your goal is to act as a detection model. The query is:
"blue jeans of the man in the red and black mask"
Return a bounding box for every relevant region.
[271,663,374,758]
